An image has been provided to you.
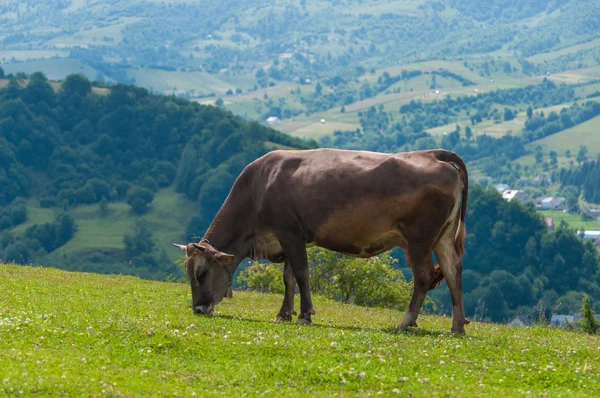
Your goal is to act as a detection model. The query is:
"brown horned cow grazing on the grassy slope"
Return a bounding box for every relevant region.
[175,149,469,333]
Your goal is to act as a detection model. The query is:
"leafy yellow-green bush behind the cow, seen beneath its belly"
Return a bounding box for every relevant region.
[239,248,412,308]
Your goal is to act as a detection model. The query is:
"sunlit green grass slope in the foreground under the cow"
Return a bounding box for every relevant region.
[0,264,600,397]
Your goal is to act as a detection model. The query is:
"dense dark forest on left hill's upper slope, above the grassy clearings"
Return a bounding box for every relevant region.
[0,73,316,258]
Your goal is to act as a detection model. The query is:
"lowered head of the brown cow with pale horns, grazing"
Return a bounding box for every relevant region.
[173,242,234,315]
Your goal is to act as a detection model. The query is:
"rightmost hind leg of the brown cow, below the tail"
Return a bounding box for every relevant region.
[433,234,469,333]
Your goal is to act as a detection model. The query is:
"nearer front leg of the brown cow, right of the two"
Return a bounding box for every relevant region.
[281,239,315,325]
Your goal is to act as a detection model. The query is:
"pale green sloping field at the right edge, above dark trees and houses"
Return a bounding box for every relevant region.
[517,116,600,164]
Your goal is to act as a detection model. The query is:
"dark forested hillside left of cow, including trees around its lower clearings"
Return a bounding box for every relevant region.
[0,73,314,277]
